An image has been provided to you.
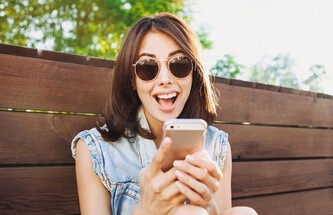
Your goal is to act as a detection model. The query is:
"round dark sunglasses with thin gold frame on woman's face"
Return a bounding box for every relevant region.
[133,56,193,81]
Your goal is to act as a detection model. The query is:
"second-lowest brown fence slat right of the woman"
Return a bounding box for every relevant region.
[232,159,333,198]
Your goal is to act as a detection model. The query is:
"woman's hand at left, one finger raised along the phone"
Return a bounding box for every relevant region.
[133,137,186,214]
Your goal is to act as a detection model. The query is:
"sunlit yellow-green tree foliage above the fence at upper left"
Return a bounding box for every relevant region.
[0,0,209,59]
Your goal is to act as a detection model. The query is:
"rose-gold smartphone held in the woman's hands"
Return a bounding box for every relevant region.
[162,119,207,171]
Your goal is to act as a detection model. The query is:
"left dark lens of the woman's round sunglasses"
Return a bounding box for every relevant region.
[135,59,158,81]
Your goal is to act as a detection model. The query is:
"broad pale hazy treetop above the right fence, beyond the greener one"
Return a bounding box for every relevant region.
[249,54,299,88]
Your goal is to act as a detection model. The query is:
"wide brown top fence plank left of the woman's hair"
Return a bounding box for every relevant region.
[0,54,111,113]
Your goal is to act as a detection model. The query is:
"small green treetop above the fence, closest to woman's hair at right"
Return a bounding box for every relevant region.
[210,55,244,78]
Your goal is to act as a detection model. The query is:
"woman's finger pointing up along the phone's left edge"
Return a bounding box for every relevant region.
[150,137,171,175]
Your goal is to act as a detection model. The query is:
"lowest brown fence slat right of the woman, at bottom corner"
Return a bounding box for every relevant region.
[233,188,333,215]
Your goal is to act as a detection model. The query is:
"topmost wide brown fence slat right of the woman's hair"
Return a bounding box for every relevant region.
[215,83,333,128]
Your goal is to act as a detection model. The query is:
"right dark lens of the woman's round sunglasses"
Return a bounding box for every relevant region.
[169,56,193,78]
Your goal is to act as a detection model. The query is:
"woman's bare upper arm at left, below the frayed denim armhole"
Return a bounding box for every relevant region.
[75,139,111,215]
